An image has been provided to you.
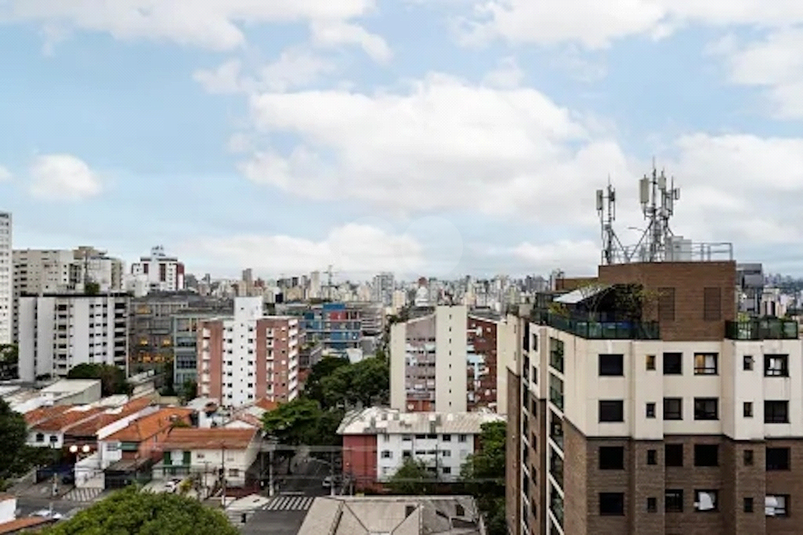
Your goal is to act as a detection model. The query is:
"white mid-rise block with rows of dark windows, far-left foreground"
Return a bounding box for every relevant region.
[19,293,129,381]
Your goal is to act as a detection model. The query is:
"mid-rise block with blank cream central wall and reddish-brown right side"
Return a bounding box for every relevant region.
[390,305,507,413]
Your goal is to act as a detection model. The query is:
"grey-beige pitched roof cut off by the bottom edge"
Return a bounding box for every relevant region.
[298,496,486,535]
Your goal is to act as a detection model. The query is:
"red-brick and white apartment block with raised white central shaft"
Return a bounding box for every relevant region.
[197,297,301,407]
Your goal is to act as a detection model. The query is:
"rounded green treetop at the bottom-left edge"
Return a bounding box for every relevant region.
[44,487,239,535]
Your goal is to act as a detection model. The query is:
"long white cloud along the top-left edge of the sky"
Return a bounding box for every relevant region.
[0,0,375,50]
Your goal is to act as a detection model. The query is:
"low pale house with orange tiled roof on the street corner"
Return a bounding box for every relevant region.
[154,427,261,488]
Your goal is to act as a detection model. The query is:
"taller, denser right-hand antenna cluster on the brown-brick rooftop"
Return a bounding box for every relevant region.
[634,158,680,262]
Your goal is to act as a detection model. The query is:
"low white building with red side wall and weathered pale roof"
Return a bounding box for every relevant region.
[337,407,505,486]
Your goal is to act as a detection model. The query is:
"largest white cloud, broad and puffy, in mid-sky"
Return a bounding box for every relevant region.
[242,74,627,224]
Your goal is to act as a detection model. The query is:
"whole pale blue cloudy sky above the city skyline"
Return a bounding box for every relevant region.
[0,0,803,277]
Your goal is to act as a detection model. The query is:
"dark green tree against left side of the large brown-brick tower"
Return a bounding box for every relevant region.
[460,422,507,535]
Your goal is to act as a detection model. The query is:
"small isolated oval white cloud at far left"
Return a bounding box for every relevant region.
[30,154,103,201]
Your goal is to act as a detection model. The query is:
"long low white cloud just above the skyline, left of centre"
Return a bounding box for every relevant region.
[180,224,424,276]
